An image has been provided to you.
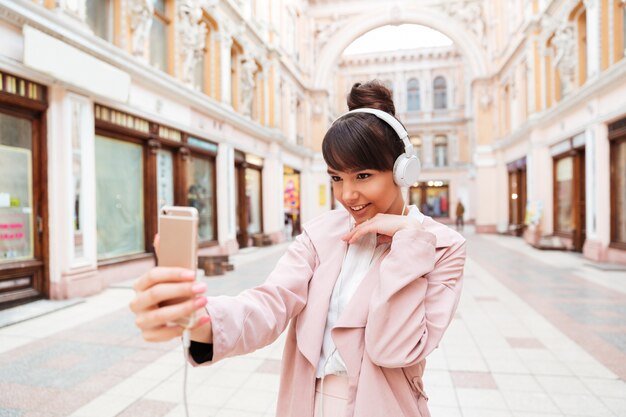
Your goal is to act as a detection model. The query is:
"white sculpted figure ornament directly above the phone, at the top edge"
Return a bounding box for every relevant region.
[177,0,208,85]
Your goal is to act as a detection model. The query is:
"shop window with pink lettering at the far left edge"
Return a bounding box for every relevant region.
[0,113,34,264]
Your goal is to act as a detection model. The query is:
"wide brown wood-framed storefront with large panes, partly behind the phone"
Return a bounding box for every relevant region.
[95,105,217,266]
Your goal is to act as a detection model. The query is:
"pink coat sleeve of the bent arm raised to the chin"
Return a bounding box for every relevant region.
[365,230,465,368]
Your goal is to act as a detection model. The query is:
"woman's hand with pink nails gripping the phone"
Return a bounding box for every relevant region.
[129,267,211,342]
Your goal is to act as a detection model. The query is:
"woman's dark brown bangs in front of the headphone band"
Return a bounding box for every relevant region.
[322,114,400,172]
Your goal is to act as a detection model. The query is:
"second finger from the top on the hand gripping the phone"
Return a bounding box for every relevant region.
[129,282,206,313]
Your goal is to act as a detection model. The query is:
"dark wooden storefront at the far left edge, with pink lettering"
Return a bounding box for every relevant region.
[0,72,49,309]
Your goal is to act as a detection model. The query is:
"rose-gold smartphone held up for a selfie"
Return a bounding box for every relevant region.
[157,206,198,327]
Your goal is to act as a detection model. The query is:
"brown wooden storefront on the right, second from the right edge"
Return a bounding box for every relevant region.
[551,133,586,252]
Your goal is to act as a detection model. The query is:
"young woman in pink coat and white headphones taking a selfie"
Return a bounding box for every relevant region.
[131,81,465,417]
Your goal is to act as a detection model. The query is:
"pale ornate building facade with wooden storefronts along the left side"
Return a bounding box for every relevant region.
[0,0,328,308]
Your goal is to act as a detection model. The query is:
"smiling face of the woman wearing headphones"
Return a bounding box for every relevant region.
[328,169,404,224]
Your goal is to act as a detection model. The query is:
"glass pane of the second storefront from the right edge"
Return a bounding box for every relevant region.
[554,156,574,233]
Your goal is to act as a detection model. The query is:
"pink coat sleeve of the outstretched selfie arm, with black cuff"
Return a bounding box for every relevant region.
[190,232,319,365]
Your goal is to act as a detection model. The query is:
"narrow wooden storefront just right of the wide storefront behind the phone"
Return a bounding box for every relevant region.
[235,151,263,248]
